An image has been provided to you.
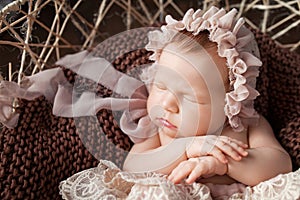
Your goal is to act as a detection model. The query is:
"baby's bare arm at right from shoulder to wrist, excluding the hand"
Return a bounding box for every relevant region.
[227,116,292,186]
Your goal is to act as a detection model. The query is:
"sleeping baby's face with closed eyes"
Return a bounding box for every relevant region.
[147,47,225,138]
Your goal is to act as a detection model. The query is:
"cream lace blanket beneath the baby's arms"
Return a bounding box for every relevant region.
[59,160,300,200]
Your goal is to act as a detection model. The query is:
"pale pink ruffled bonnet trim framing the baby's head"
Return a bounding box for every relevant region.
[146,7,262,132]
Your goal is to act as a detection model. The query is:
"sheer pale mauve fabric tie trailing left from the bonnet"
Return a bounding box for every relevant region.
[0,51,157,142]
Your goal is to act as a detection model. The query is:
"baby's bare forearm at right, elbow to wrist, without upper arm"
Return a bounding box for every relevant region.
[227,147,292,186]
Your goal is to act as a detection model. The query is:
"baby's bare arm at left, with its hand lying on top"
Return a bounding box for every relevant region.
[123,134,244,175]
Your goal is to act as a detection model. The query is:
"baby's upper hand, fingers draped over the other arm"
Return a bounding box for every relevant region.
[186,135,248,163]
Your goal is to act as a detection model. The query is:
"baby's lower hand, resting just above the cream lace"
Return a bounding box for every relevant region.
[168,156,227,184]
